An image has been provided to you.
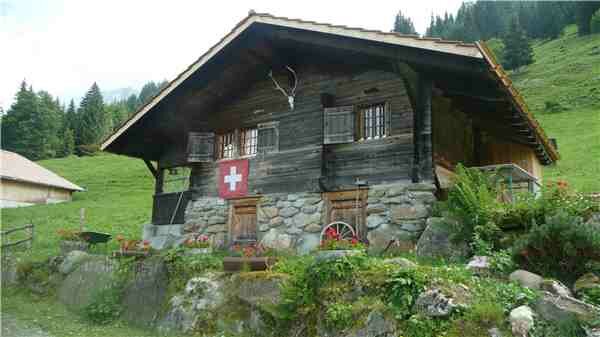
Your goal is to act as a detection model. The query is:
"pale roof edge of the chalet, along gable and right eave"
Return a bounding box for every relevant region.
[100,11,559,163]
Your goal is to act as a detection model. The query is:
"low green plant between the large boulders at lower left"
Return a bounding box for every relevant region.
[83,287,123,324]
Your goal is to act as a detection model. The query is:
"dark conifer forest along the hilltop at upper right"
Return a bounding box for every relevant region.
[393,0,600,70]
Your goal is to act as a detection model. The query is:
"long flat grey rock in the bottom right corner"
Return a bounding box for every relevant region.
[535,291,600,323]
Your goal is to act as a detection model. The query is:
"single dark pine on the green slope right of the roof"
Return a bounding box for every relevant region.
[502,16,533,70]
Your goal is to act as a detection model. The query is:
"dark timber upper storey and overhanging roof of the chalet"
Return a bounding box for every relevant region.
[102,14,557,224]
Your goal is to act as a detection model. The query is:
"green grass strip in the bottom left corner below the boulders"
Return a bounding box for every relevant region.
[2,288,185,337]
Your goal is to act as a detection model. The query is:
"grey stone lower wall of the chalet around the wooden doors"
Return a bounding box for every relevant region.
[178,183,435,253]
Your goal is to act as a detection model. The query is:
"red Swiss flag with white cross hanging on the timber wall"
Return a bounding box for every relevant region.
[219,159,248,199]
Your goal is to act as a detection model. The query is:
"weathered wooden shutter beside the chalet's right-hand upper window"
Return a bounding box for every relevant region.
[323,106,354,144]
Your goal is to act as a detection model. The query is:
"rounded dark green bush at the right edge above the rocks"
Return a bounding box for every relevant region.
[514,211,600,283]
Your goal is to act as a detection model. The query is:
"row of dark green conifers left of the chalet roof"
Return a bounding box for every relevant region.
[0,81,167,160]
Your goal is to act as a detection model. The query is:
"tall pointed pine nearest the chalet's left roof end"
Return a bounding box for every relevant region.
[79,82,110,145]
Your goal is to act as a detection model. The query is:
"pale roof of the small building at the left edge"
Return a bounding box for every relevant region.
[0,150,84,191]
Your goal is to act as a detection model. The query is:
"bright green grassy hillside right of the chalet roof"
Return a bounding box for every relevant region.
[511,26,600,192]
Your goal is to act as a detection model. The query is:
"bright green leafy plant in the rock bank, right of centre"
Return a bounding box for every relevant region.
[386,268,427,319]
